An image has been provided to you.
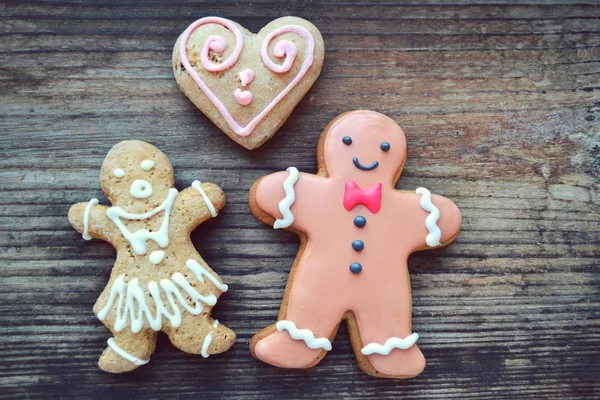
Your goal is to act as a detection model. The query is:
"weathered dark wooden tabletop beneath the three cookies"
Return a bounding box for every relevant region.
[0,0,600,399]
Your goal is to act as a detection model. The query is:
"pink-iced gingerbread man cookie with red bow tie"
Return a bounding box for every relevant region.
[250,111,461,378]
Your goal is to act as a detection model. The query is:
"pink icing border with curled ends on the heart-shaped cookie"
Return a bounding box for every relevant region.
[179,17,315,136]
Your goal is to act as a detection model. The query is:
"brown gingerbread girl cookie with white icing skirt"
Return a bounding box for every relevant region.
[69,140,235,373]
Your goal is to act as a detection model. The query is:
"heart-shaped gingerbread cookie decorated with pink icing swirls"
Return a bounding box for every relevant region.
[173,17,324,150]
